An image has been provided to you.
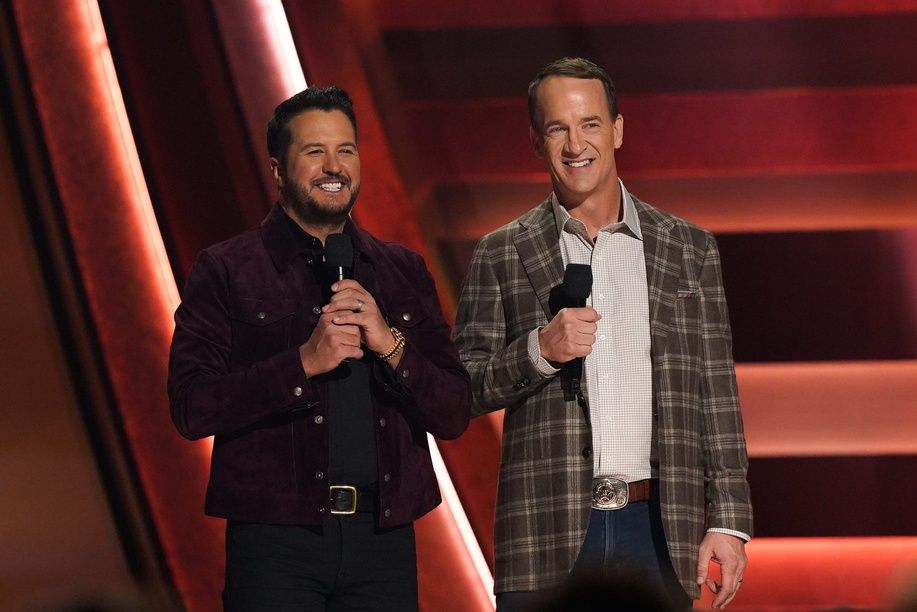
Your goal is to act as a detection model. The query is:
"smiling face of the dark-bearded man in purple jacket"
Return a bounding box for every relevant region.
[271,110,360,234]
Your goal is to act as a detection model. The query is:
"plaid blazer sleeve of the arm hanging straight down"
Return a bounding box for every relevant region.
[699,234,752,536]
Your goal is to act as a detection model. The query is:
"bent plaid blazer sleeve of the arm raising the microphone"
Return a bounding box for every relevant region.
[455,238,551,416]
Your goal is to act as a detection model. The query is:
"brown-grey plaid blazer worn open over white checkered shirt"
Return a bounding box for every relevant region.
[454,198,752,598]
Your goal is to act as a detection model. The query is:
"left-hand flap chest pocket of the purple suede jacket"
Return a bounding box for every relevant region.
[229,298,297,364]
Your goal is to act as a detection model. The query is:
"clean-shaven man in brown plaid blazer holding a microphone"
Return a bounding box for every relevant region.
[454,58,752,610]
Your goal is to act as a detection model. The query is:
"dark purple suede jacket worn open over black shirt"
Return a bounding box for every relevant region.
[169,205,471,527]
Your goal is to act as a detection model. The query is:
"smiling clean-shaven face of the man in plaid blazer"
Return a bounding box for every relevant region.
[531,76,624,208]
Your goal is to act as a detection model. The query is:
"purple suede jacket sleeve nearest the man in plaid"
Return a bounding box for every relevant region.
[377,253,471,440]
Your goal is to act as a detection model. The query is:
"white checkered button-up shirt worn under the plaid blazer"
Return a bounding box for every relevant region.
[529,183,653,482]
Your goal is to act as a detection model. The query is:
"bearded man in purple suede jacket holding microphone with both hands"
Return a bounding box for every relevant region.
[169,87,471,610]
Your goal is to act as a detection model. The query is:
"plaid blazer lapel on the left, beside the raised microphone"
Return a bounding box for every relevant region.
[514,198,564,320]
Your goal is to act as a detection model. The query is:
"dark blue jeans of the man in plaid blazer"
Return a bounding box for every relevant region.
[497,499,691,612]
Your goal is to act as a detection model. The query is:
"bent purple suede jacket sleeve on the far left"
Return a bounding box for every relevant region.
[168,251,317,440]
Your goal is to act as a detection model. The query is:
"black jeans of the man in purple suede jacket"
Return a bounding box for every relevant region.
[223,513,417,612]
